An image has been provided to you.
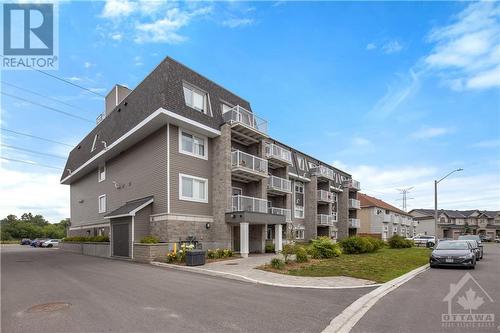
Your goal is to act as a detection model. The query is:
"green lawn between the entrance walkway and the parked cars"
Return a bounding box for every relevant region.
[266,247,431,282]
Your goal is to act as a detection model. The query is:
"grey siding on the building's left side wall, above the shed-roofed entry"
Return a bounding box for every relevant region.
[70,128,167,227]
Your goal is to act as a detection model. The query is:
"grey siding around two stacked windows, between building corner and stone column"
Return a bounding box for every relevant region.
[170,125,213,216]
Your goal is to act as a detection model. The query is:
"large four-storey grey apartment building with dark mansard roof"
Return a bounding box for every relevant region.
[61,57,360,258]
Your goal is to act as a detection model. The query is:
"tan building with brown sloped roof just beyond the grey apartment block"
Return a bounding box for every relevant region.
[358,193,416,240]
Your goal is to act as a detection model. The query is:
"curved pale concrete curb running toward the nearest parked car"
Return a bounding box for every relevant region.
[322,264,429,333]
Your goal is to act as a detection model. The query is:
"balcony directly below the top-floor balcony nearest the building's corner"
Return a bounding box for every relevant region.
[231,150,268,183]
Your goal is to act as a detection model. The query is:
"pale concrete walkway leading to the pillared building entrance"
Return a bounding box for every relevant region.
[152,254,378,289]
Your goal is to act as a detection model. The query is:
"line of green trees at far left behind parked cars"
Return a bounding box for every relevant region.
[0,213,70,241]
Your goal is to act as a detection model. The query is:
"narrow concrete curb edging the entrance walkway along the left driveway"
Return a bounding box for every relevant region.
[150,261,383,289]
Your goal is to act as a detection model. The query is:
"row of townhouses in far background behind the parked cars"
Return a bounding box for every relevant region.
[409,209,500,239]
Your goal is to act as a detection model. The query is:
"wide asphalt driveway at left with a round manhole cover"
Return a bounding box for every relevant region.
[1,246,372,333]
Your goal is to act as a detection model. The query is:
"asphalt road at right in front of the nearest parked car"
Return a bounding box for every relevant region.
[351,243,500,333]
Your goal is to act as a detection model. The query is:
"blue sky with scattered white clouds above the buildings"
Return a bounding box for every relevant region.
[0,0,500,222]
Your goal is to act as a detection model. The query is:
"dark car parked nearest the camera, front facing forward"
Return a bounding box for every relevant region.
[429,240,476,269]
